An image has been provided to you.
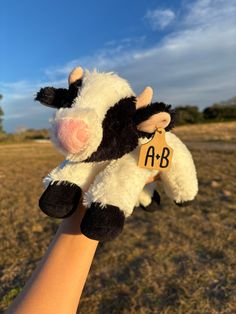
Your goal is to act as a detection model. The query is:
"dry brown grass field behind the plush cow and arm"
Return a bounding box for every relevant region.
[0,123,236,314]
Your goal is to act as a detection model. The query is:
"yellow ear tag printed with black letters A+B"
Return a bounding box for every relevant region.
[138,128,173,171]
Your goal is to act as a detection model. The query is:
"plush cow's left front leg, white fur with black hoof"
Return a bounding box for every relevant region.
[39,160,108,218]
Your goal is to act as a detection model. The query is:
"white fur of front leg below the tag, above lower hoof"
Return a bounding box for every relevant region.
[84,148,157,217]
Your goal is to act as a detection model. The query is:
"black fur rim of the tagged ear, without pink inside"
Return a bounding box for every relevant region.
[134,102,175,138]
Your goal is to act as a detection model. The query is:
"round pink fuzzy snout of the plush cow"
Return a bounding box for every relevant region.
[56,118,89,154]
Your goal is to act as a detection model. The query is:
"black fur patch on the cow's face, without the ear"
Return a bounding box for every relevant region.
[85,97,138,162]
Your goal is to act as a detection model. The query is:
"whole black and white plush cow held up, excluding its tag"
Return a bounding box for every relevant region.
[35,68,198,241]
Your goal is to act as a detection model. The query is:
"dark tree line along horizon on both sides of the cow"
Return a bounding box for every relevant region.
[0,94,236,142]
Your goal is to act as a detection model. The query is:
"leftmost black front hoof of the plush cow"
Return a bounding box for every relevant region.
[39,181,82,218]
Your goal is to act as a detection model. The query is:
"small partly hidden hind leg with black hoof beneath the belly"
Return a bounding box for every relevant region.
[136,182,161,212]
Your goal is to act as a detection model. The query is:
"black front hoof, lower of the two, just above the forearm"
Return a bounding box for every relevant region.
[80,203,125,242]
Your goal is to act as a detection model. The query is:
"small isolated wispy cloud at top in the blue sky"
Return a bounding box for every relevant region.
[145,9,175,31]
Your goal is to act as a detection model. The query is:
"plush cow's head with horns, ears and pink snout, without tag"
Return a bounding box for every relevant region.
[35,67,174,162]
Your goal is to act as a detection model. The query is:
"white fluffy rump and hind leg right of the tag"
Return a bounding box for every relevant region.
[160,132,198,205]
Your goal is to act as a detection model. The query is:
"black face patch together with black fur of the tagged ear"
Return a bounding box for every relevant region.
[84,97,174,162]
